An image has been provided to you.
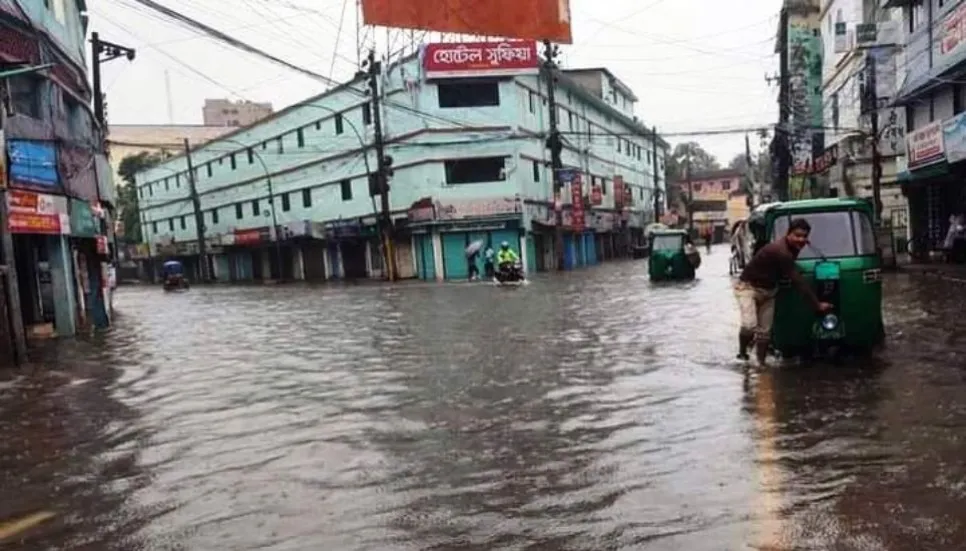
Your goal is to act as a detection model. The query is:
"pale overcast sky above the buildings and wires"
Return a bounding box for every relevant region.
[88,0,780,163]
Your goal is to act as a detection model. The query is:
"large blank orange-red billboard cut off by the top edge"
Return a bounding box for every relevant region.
[362,0,573,44]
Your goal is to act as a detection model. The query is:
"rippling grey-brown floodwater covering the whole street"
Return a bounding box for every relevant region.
[0,248,966,551]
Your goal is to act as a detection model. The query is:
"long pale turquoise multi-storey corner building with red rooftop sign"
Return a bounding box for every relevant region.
[136,42,668,281]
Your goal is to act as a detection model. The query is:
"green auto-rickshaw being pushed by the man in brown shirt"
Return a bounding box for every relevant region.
[748,198,885,357]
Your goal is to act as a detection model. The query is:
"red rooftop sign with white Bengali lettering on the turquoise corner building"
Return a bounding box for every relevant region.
[423,40,540,78]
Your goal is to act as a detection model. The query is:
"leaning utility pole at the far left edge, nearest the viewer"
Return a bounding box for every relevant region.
[0,82,27,365]
